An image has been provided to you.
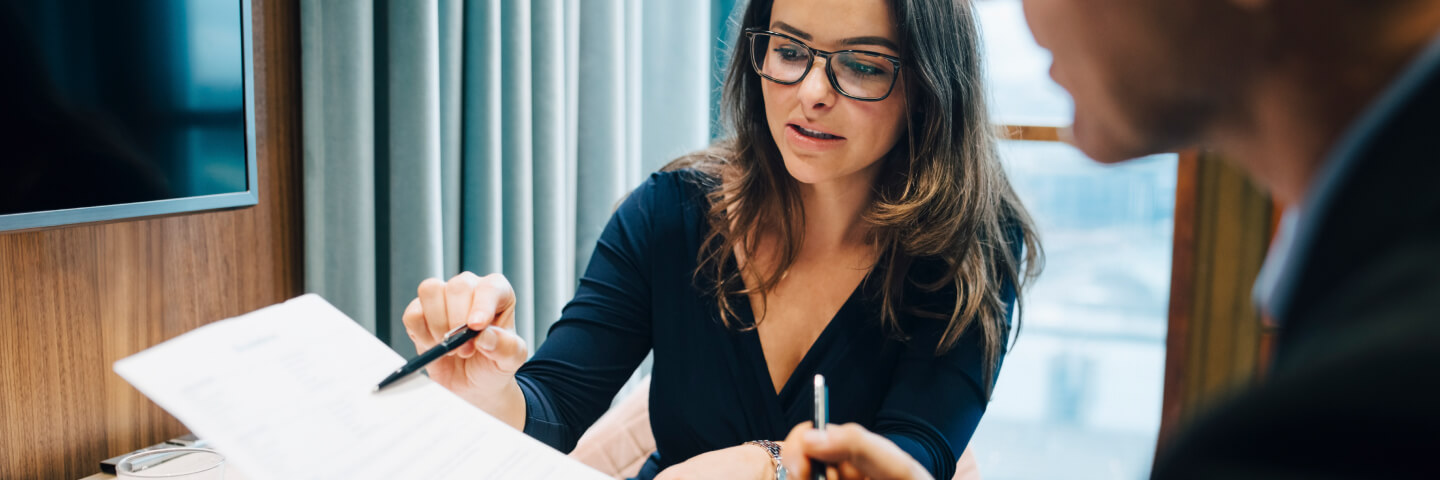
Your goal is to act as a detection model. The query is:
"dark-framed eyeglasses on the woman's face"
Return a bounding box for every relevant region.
[744,29,900,102]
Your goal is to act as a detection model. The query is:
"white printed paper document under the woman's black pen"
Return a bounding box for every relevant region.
[115,294,609,480]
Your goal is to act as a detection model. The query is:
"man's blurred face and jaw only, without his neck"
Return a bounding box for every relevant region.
[1024,0,1266,163]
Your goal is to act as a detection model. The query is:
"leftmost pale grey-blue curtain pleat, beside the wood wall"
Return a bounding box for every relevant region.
[300,0,377,332]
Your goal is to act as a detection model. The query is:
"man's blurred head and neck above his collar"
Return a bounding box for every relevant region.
[1024,0,1440,172]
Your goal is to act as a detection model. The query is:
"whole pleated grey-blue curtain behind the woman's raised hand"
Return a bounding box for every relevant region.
[301,0,714,355]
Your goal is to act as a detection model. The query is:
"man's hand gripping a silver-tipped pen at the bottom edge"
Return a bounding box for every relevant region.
[780,422,930,480]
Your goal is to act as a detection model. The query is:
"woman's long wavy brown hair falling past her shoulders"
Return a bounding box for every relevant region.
[667,0,1043,389]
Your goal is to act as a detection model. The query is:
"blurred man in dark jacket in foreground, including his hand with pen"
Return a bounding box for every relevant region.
[786,0,1440,479]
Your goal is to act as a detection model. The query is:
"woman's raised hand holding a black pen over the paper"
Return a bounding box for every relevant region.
[402,271,530,430]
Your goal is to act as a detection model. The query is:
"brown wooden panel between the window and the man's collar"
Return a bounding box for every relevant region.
[1158,153,1274,450]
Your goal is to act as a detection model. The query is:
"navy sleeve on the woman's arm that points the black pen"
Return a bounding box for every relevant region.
[516,176,672,453]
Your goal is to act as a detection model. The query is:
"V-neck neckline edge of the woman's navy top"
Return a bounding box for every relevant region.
[730,258,878,400]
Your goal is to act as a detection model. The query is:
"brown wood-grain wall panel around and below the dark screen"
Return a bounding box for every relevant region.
[0,0,302,479]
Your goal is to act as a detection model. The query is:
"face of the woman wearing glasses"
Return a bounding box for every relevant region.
[760,0,904,185]
